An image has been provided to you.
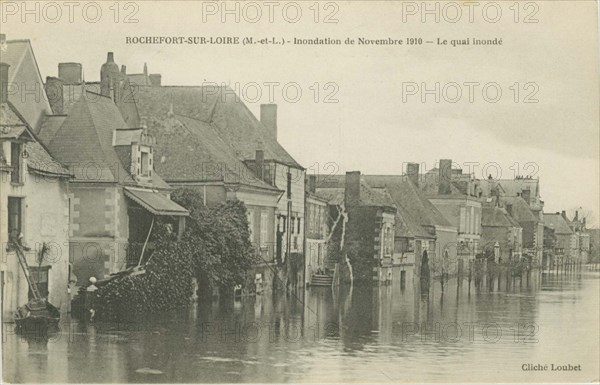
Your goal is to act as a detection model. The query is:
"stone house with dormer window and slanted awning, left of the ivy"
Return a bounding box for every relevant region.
[37,54,188,285]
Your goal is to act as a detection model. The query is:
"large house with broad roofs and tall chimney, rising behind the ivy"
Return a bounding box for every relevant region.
[131,73,305,288]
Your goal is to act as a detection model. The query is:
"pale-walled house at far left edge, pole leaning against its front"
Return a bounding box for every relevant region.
[0,61,71,321]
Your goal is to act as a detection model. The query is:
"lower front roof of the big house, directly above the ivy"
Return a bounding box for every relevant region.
[147,110,279,191]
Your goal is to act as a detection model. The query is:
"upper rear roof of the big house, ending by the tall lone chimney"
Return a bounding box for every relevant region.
[136,86,302,168]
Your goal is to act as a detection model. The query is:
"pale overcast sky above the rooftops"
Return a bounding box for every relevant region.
[2,1,600,224]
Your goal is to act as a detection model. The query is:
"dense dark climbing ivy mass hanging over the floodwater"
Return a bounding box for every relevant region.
[94,189,257,319]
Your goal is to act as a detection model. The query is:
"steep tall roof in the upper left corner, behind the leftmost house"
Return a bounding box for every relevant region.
[0,39,52,130]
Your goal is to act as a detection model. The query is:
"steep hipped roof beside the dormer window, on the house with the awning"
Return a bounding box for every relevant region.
[40,91,169,189]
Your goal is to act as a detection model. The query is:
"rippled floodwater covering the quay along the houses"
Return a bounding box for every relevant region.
[3,268,600,383]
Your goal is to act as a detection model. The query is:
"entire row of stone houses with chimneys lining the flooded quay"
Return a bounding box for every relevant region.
[0,35,589,319]
